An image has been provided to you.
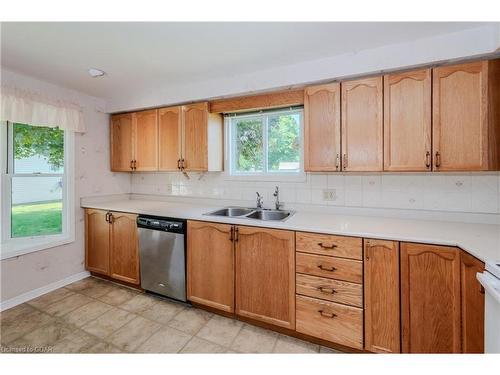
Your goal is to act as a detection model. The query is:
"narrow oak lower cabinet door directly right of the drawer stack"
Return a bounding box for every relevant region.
[364,239,401,353]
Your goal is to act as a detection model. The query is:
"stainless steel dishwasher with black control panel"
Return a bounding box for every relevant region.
[137,216,186,302]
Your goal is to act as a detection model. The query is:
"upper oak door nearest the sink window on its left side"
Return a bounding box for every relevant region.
[182,102,208,171]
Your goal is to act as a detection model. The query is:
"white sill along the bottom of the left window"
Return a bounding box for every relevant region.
[0,236,75,260]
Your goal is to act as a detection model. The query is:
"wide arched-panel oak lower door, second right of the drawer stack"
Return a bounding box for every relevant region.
[401,243,461,353]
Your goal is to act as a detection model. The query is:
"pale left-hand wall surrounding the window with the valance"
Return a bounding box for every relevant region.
[0,69,130,301]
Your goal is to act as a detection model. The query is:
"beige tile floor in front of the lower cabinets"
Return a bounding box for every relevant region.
[0,277,344,353]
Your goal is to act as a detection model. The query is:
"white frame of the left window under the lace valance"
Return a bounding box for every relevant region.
[0,121,75,260]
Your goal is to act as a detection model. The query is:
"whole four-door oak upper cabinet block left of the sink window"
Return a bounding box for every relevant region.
[111,102,223,172]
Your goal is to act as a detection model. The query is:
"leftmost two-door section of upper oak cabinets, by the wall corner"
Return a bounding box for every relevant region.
[111,109,158,172]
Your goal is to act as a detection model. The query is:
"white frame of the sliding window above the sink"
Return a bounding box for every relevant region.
[224,106,307,182]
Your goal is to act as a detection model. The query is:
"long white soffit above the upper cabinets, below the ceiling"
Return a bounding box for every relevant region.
[106,24,500,113]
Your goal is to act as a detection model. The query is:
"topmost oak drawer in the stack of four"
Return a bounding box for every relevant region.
[295,232,363,260]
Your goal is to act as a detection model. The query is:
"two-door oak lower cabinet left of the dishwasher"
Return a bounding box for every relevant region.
[85,209,141,285]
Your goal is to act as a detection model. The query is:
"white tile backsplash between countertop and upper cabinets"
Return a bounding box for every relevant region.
[131,172,500,214]
